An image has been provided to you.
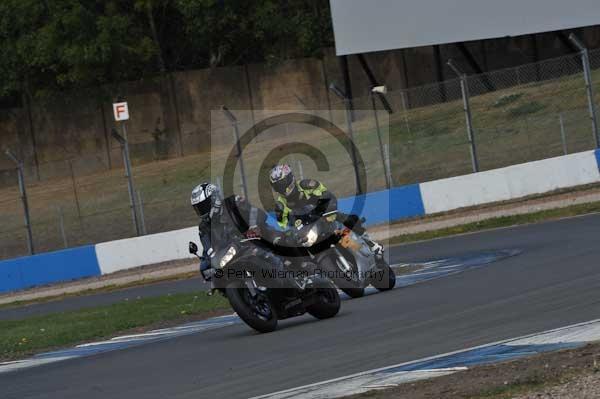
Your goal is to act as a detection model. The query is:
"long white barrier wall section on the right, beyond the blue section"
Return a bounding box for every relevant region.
[420,151,600,214]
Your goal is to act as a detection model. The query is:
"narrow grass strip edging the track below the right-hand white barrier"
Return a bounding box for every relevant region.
[389,202,600,245]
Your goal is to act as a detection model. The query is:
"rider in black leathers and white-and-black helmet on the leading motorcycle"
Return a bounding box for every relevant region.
[191,183,296,281]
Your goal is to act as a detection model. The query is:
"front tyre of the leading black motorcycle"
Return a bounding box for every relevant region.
[225,281,277,333]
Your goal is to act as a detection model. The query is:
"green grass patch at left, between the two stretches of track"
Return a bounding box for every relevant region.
[0,292,229,360]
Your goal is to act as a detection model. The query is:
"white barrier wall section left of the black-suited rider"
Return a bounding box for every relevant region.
[96,227,202,274]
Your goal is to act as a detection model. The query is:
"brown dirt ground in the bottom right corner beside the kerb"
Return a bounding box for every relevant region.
[347,343,600,399]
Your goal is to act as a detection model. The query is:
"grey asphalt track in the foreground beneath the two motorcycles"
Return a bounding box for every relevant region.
[0,215,600,399]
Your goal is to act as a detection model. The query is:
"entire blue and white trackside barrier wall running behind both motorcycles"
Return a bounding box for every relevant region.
[0,150,600,293]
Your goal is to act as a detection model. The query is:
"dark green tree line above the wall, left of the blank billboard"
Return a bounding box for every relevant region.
[0,0,333,98]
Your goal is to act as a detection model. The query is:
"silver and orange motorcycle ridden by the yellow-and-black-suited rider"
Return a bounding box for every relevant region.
[293,206,396,298]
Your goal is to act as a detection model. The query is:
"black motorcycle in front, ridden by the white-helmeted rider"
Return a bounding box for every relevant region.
[189,238,341,333]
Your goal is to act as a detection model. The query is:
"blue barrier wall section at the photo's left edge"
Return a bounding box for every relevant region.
[0,245,101,292]
